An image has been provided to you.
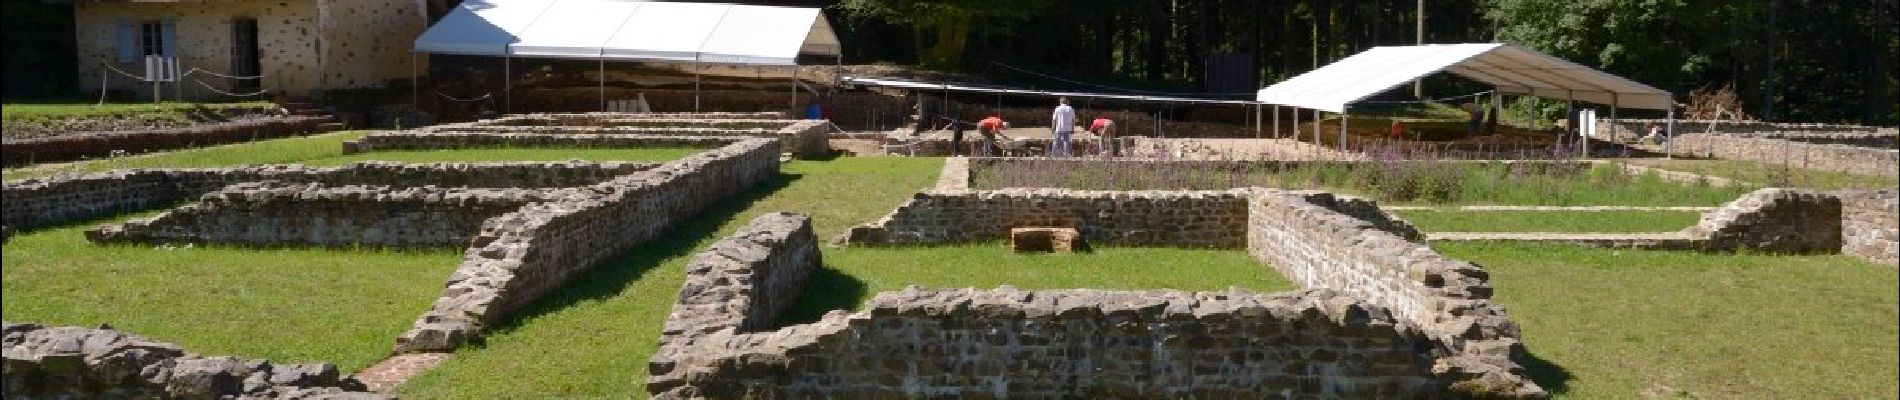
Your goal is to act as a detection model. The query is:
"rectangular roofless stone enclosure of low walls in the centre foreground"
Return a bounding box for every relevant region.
[668,181,1547,398]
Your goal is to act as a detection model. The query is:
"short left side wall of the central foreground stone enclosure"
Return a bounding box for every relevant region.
[648,212,821,392]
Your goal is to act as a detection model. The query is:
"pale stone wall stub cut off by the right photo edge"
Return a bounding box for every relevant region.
[1835,190,1900,267]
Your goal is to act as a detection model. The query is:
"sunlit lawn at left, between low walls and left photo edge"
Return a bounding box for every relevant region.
[0,216,462,373]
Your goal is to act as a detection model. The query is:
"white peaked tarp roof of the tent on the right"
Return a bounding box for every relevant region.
[1256,44,1672,112]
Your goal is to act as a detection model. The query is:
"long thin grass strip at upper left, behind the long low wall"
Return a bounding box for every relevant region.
[6,131,705,180]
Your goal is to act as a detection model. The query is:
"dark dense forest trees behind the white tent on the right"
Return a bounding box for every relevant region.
[840,0,1900,125]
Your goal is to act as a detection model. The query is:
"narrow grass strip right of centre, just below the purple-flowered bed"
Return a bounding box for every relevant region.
[1393,210,1702,231]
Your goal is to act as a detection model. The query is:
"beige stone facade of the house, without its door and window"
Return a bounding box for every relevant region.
[74,0,428,99]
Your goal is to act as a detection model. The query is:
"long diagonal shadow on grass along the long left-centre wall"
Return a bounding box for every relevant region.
[478,173,802,334]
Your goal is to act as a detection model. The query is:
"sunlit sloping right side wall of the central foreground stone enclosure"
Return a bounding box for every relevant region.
[1246,191,1543,396]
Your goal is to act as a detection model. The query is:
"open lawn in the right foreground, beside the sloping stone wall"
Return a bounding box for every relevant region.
[1435,243,1900,398]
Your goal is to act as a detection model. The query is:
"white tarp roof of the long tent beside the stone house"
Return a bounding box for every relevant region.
[416,0,842,64]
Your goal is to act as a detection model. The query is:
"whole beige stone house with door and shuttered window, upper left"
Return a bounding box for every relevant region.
[70,0,431,100]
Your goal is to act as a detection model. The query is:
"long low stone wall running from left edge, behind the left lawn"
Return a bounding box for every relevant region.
[0,161,657,229]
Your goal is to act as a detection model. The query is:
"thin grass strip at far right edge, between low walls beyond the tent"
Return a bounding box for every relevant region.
[1630,159,1900,190]
